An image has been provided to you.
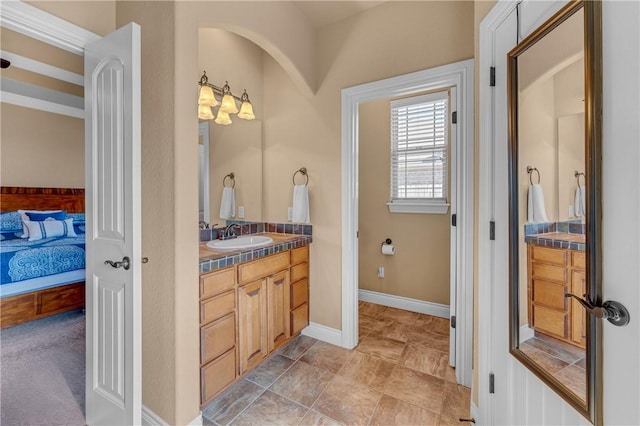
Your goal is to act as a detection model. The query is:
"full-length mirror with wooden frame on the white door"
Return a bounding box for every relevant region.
[508,1,602,423]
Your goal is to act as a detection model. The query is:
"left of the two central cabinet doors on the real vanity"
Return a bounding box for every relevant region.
[238,279,269,374]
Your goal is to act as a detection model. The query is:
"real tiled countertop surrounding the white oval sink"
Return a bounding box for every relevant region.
[200,232,311,274]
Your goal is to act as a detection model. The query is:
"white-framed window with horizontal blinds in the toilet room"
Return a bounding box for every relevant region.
[388,91,449,213]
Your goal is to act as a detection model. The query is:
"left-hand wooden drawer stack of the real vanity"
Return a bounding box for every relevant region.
[200,266,238,405]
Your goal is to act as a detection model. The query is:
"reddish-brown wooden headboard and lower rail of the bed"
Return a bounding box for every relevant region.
[0,186,85,328]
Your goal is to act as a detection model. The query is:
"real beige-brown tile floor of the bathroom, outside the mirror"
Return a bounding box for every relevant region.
[203,302,470,426]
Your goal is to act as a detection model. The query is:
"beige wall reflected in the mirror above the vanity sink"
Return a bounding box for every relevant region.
[198,28,264,225]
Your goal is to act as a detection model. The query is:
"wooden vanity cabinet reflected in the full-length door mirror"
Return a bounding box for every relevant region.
[527,244,586,347]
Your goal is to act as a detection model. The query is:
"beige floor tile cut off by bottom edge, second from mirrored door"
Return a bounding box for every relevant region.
[370,395,440,426]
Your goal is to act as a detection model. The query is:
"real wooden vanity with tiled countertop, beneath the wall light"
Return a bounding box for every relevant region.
[200,233,311,406]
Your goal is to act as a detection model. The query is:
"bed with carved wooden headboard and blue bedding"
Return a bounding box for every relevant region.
[0,186,85,328]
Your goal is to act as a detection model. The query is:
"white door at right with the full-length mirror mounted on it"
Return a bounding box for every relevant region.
[478,1,640,425]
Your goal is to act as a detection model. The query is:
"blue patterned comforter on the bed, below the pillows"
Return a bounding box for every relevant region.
[0,234,85,285]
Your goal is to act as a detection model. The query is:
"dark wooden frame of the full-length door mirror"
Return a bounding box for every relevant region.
[507,0,603,424]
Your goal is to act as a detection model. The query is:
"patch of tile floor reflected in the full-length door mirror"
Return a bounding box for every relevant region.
[520,333,587,401]
